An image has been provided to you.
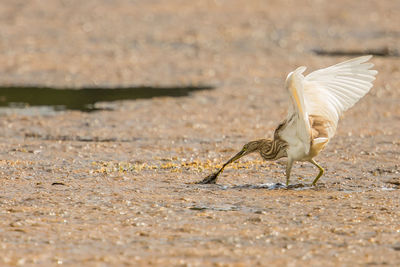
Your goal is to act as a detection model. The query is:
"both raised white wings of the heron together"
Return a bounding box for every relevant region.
[286,56,378,154]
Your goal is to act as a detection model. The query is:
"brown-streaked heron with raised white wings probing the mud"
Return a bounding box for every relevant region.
[198,55,378,187]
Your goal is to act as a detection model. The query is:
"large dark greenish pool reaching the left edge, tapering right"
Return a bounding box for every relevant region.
[0,86,214,112]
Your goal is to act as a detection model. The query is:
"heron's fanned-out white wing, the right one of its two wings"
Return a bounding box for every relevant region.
[303,56,378,138]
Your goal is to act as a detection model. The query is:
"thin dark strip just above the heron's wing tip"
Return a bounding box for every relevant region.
[311,47,400,57]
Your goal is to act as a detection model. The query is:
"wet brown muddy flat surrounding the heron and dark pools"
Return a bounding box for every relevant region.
[0,0,400,266]
